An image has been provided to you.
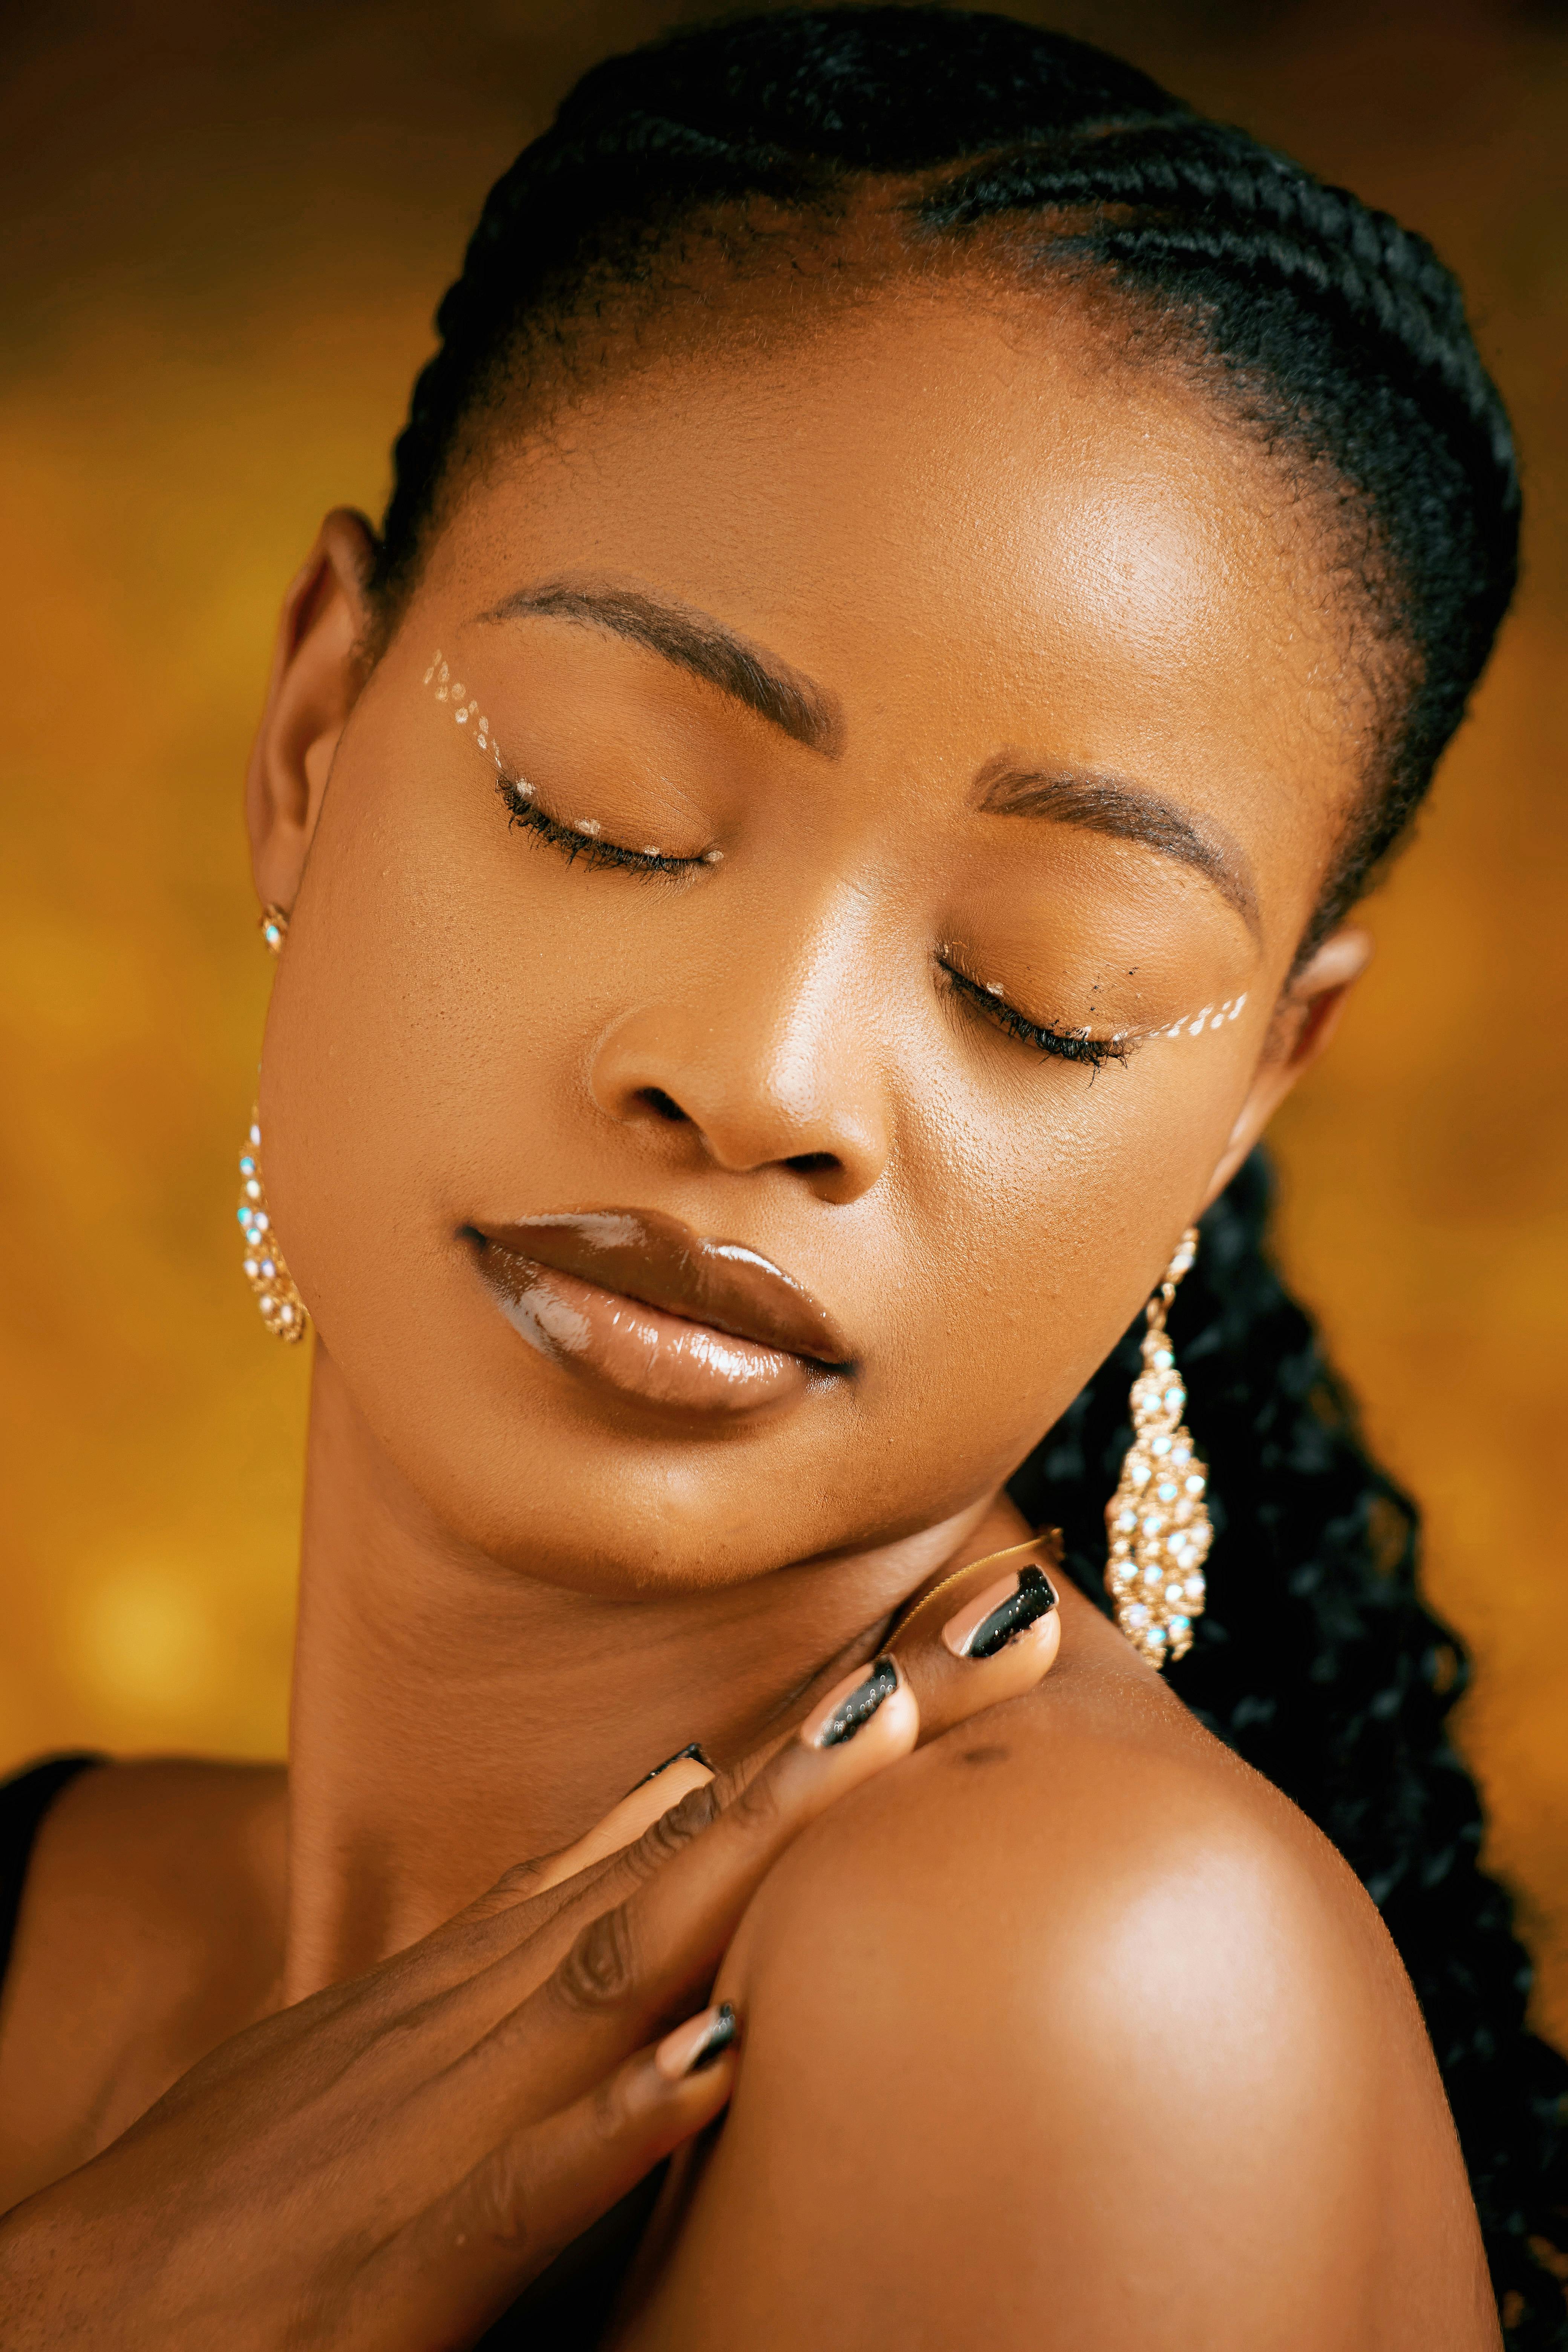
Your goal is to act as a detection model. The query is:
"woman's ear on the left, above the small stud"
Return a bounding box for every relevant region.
[245,506,376,913]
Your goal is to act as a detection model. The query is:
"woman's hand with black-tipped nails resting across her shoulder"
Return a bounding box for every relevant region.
[0,1533,1055,2352]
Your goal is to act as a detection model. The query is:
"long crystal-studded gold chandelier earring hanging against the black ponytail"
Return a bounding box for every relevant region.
[1105,1225,1213,1665]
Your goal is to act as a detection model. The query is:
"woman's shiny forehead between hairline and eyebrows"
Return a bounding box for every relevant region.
[428,285,1366,922]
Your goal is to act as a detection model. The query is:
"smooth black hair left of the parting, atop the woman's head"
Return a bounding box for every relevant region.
[374,7,1178,605]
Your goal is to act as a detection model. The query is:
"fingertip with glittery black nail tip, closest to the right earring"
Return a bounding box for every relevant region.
[889,1529,1063,1745]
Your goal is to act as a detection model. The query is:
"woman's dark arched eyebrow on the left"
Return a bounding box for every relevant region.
[482,581,844,760]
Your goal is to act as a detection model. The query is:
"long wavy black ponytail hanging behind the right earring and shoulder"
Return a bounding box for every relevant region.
[1009,1153,1568,2352]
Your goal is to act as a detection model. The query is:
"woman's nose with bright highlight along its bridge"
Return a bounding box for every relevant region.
[588,903,893,1202]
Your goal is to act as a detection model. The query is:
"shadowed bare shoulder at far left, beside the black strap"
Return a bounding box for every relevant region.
[0,1757,285,2211]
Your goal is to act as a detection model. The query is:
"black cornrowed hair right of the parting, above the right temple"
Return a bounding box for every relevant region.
[914,115,1519,926]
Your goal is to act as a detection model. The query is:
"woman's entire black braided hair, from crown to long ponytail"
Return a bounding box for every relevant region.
[374,7,1568,2352]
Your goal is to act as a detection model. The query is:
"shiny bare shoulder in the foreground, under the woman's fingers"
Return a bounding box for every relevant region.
[628,1646,1498,2352]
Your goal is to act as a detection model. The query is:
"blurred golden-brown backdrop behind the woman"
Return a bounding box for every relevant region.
[0,0,1568,2046]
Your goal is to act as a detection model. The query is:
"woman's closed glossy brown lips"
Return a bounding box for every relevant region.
[463,1209,853,1411]
